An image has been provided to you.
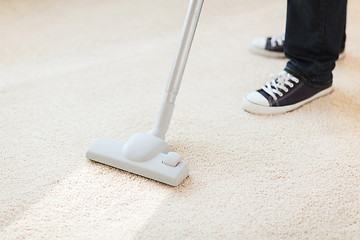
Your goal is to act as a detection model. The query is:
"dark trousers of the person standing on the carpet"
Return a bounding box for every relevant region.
[284,0,347,86]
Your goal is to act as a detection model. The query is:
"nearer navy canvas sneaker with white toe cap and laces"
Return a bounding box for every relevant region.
[242,71,333,114]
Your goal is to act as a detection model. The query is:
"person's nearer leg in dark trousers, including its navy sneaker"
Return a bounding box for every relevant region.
[243,0,347,114]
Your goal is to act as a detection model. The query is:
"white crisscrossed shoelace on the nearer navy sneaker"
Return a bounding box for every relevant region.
[262,71,299,101]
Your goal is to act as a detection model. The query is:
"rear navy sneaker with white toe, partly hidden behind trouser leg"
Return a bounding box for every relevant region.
[250,35,345,60]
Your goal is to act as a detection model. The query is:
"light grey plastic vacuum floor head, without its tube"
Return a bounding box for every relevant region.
[86,133,189,186]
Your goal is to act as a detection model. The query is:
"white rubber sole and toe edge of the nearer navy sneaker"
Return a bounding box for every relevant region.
[242,86,334,115]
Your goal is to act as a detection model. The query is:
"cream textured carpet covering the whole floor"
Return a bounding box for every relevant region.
[0,0,360,239]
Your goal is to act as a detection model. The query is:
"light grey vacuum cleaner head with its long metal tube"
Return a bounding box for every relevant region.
[86,0,203,186]
